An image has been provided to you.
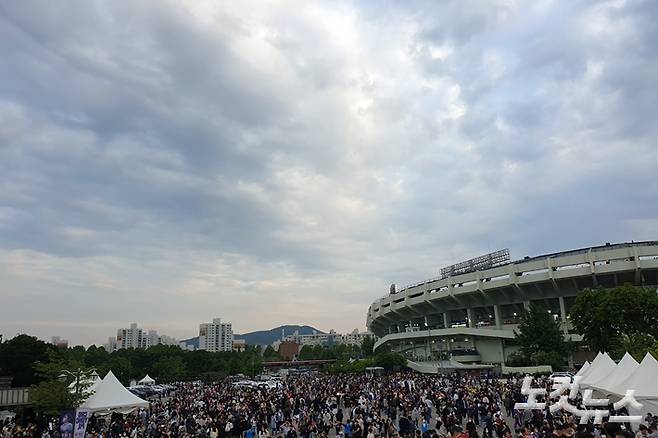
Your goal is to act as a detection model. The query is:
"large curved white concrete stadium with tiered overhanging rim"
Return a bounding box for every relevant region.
[367,241,658,369]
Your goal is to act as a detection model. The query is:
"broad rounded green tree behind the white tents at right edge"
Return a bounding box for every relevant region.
[570,284,658,351]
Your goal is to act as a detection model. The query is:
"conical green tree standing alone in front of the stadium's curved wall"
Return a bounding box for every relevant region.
[514,305,570,366]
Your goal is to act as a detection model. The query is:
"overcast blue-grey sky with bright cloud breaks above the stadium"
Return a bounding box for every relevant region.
[0,0,658,350]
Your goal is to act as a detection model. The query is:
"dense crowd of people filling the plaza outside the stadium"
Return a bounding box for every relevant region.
[1,373,658,438]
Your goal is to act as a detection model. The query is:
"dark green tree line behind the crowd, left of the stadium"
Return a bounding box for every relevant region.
[0,334,405,415]
